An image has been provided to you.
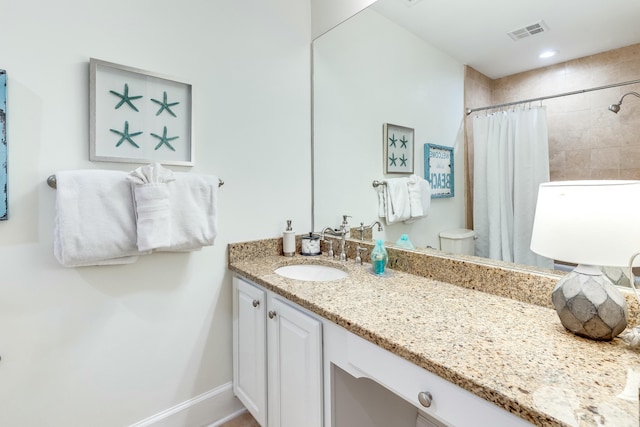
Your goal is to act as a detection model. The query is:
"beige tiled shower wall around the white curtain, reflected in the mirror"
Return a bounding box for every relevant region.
[465,44,640,226]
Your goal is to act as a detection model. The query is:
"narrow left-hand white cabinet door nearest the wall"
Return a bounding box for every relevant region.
[233,277,267,426]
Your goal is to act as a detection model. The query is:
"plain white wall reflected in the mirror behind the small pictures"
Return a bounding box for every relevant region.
[313,6,465,248]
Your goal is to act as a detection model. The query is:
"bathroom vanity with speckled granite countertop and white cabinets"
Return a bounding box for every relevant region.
[229,239,640,427]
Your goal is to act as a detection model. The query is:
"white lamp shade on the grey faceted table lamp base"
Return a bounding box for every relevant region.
[531,180,640,267]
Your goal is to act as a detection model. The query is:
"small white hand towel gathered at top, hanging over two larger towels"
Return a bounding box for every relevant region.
[127,163,175,252]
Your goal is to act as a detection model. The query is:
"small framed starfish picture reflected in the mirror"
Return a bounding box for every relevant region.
[382,123,413,174]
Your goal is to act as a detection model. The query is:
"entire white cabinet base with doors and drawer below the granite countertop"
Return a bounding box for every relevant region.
[233,277,531,427]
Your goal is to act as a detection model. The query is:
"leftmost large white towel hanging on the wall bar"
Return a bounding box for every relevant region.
[54,170,148,267]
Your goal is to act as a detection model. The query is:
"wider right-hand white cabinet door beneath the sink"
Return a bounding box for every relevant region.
[267,297,322,427]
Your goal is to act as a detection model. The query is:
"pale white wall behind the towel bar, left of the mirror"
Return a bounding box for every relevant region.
[0,0,311,427]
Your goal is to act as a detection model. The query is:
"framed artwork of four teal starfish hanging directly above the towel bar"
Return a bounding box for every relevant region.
[89,58,194,166]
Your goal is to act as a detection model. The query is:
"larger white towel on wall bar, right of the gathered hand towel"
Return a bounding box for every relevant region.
[160,172,219,251]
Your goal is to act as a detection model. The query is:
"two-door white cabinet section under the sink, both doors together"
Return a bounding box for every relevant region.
[233,277,323,427]
